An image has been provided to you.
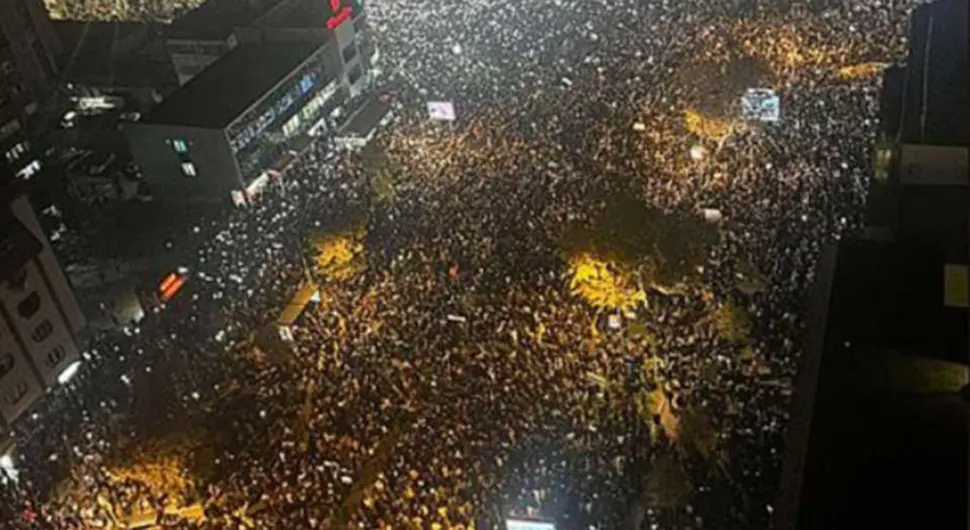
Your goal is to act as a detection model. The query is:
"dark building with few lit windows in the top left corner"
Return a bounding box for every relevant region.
[0,0,60,178]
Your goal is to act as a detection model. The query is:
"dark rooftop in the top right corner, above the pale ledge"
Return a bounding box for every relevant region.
[901,0,970,145]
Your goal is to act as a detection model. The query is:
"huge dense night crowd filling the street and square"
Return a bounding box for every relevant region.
[4,0,913,529]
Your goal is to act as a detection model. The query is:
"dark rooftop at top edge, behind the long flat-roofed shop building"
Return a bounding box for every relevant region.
[165,0,285,40]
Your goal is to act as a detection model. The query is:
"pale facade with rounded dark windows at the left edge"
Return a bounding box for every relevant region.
[0,182,85,425]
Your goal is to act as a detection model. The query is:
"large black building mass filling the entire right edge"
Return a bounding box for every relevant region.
[774,0,970,530]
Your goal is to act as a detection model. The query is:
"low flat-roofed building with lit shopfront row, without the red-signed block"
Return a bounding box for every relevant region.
[125,43,340,202]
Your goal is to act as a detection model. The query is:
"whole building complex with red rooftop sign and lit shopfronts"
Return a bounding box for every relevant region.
[125,0,388,204]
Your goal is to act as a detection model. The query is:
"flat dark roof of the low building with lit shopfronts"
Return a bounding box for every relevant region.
[141,42,321,129]
